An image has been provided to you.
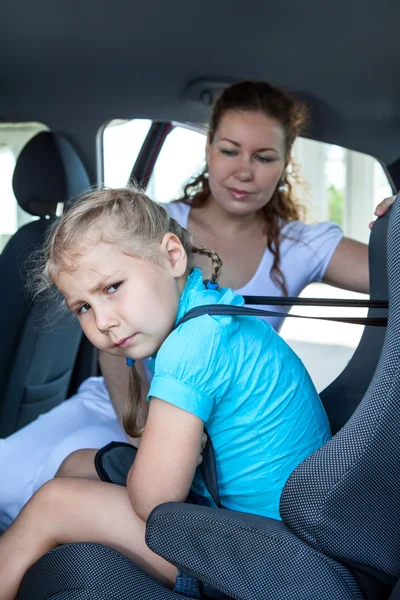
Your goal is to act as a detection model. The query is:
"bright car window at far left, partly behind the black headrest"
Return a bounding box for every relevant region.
[0,123,48,252]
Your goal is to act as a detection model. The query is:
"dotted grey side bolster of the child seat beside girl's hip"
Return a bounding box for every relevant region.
[146,503,363,600]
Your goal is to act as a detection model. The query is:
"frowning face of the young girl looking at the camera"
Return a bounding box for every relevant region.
[55,233,187,359]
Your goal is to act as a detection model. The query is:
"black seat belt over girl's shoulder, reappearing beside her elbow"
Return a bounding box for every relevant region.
[174,296,387,508]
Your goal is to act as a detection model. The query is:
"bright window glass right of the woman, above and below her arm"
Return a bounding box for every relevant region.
[281,139,393,391]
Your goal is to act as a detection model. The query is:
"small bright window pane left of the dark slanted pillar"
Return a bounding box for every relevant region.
[103,119,151,187]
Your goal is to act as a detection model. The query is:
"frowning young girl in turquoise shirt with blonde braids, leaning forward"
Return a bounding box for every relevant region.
[0,189,330,600]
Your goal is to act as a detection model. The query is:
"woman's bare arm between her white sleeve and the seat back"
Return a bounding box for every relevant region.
[323,238,369,294]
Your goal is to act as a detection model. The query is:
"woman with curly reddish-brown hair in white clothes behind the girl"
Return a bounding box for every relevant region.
[0,82,392,527]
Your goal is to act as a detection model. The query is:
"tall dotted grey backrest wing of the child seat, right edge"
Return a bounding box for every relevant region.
[280,195,400,579]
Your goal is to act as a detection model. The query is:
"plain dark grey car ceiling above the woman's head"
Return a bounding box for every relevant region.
[0,0,400,164]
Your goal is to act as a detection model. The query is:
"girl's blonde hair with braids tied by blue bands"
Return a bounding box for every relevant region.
[34,187,222,437]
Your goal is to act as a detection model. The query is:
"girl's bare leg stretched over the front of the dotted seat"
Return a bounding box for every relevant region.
[0,478,177,600]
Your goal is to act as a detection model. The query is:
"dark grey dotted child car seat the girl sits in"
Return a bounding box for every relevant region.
[18,198,400,600]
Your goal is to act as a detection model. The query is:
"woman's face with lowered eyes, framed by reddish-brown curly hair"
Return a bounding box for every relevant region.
[206,111,286,215]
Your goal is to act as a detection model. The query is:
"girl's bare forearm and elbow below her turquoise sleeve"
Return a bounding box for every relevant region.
[127,397,204,521]
